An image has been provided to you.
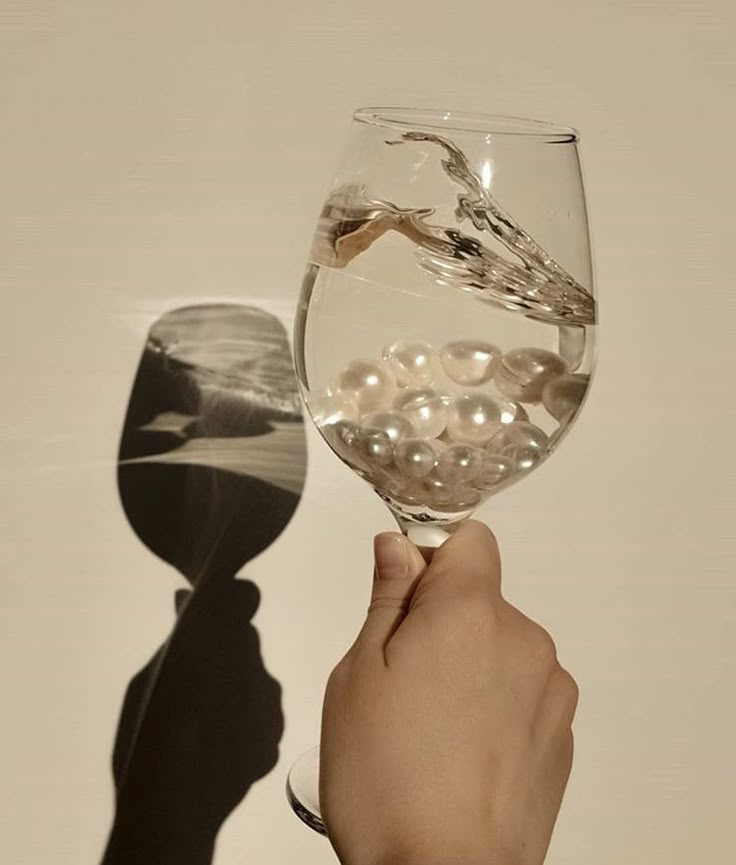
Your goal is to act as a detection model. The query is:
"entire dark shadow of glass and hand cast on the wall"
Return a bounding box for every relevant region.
[102,304,306,865]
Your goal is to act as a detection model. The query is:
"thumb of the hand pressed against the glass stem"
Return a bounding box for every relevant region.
[359,532,426,649]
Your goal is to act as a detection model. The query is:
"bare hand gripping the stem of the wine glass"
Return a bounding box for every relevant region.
[320,521,577,865]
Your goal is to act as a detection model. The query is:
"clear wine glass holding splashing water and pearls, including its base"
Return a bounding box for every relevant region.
[287,108,597,832]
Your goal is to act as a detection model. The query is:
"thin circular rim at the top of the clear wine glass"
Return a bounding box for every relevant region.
[353,106,580,144]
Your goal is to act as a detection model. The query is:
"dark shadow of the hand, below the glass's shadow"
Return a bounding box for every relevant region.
[104,580,283,865]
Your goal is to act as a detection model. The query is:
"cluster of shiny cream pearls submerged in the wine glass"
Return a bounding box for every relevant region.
[309,340,588,513]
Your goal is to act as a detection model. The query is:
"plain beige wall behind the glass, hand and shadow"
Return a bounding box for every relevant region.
[0,0,736,865]
